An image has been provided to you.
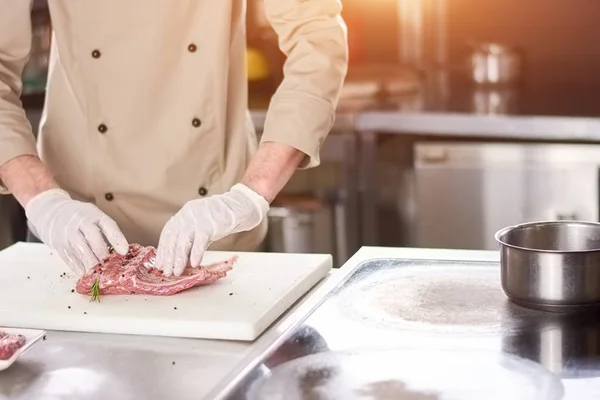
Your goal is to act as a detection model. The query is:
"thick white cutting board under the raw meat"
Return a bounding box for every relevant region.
[0,242,332,341]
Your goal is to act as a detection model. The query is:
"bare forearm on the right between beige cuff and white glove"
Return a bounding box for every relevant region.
[242,142,306,203]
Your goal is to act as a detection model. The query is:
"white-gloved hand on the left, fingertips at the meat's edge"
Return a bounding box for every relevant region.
[25,189,129,275]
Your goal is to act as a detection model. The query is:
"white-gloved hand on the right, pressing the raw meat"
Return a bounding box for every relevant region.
[155,184,269,276]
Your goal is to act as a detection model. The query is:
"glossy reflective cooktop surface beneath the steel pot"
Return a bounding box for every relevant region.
[231,252,600,400]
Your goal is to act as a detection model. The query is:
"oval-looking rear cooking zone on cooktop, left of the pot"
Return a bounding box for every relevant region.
[339,263,532,334]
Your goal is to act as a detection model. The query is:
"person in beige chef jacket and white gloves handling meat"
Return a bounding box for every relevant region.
[0,0,348,276]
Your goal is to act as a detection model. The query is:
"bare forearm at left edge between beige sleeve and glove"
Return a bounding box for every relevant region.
[0,155,58,207]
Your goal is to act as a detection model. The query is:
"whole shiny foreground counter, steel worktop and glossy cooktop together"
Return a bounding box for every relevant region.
[5,247,600,400]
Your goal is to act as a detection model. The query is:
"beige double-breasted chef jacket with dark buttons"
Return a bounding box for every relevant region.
[0,0,348,251]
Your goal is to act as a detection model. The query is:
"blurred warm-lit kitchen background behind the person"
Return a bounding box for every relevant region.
[5,0,600,265]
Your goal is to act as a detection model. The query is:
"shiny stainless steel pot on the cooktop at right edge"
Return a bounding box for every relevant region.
[495,221,600,311]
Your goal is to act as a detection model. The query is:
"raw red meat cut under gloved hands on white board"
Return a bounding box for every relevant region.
[75,244,237,296]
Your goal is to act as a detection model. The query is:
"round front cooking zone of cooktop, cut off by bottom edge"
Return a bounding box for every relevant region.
[248,348,562,400]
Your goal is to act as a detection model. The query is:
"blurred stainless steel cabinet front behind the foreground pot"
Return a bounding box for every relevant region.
[412,142,600,250]
